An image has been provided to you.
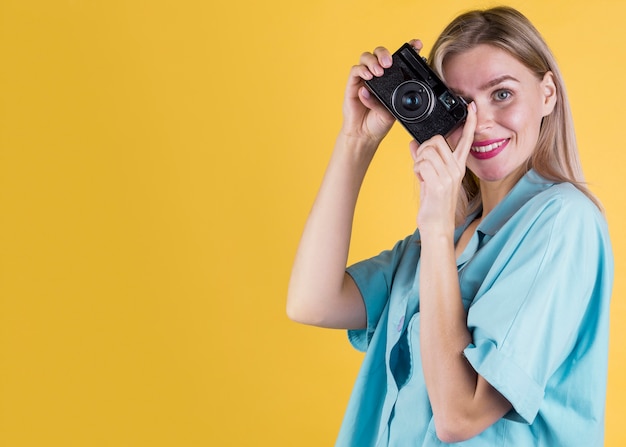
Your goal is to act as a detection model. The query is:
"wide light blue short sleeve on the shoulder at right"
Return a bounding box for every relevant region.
[464,187,612,424]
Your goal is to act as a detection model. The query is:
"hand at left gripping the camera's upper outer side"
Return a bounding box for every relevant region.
[341,39,422,146]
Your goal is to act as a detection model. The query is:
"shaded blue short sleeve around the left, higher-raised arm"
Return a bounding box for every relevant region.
[347,234,418,351]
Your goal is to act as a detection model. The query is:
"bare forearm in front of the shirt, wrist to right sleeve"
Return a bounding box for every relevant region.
[420,234,510,442]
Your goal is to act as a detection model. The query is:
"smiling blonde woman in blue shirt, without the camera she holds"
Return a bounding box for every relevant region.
[287,7,613,447]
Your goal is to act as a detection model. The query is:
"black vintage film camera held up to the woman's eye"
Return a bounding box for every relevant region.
[365,43,467,143]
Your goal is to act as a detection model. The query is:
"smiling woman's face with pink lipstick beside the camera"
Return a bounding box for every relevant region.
[443,44,556,186]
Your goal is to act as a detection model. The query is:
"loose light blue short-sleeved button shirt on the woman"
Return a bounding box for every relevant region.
[336,171,613,447]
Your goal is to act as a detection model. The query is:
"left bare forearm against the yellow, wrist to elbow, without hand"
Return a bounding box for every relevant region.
[287,134,375,327]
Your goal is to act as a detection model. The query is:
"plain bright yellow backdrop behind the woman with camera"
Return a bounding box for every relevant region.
[0,0,626,447]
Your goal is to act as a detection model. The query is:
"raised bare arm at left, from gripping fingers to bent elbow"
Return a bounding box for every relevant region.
[287,47,404,329]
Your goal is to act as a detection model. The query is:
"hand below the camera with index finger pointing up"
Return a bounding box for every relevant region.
[409,103,476,235]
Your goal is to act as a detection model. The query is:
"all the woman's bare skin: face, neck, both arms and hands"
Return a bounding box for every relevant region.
[287,40,556,443]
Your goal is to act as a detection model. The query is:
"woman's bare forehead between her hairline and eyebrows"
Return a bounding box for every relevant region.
[443,44,537,94]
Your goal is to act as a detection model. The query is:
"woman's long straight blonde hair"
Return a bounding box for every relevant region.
[429,7,602,223]
